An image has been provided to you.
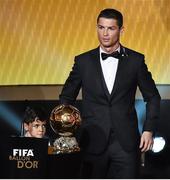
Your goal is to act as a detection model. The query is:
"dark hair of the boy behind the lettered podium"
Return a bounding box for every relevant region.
[23,106,47,124]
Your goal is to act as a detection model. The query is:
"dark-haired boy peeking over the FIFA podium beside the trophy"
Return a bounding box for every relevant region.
[23,107,46,138]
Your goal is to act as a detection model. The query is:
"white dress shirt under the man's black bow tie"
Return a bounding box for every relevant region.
[100,46,120,94]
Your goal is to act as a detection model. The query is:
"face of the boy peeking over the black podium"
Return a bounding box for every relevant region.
[24,120,46,138]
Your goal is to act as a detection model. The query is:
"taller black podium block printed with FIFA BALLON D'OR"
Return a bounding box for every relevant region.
[0,137,48,178]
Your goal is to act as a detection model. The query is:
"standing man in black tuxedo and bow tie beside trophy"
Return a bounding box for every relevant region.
[60,9,160,178]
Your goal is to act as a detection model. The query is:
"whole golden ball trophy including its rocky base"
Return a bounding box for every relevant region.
[50,104,81,154]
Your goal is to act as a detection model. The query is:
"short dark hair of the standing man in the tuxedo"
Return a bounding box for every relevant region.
[97,8,123,28]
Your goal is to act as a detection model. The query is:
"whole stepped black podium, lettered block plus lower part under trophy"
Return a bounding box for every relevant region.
[0,137,81,179]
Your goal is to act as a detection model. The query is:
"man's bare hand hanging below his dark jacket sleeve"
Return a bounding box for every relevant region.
[139,131,153,152]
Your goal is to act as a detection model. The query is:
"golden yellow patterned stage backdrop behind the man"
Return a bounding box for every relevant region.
[0,0,170,85]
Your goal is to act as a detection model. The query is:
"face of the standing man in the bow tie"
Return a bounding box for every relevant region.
[97,17,123,49]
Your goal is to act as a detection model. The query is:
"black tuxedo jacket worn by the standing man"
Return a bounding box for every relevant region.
[60,46,160,154]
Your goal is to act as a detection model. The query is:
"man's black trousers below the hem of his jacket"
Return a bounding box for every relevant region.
[81,136,140,179]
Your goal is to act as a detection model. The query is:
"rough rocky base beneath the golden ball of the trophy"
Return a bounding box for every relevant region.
[49,136,80,154]
